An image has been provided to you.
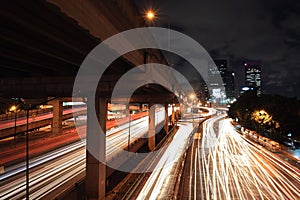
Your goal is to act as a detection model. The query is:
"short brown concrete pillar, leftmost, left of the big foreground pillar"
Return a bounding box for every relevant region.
[51,99,63,134]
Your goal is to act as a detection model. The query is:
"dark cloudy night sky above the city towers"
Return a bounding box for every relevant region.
[136,0,300,99]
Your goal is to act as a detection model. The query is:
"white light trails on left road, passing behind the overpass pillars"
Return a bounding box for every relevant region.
[0,110,165,199]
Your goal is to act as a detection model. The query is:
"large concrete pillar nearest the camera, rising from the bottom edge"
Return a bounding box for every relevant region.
[85,98,107,200]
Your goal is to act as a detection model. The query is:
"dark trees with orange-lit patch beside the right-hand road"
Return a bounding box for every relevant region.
[228,91,300,140]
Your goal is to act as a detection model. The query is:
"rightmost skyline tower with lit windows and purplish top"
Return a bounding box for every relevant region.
[244,61,261,96]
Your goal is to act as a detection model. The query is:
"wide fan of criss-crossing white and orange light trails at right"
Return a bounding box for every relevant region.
[199,115,300,199]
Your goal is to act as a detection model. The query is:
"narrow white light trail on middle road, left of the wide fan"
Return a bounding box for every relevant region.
[134,109,216,200]
